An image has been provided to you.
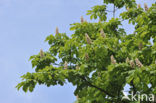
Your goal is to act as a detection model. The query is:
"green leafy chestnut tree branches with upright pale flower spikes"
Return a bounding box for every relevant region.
[16,0,156,103]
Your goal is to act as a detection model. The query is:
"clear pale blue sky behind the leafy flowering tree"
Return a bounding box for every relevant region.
[0,0,155,103]
